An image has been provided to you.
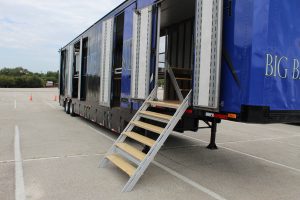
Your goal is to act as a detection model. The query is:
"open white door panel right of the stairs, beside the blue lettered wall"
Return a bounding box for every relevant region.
[193,0,223,111]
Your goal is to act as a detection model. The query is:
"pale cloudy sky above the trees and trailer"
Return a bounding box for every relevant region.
[0,0,124,72]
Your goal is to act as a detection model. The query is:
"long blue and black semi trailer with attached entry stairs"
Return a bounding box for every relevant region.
[59,0,300,191]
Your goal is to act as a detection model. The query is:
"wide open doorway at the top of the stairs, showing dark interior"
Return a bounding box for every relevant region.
[158,0,196,101]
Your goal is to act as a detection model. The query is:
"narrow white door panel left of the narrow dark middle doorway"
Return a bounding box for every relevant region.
[100,18,114,107]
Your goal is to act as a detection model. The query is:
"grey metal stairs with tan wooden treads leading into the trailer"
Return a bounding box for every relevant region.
[100,87,191,192]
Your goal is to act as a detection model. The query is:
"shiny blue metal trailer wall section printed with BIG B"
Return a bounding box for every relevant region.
[221,0,300,113]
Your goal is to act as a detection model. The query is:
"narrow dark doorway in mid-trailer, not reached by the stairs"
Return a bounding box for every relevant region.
[111,13,124,107]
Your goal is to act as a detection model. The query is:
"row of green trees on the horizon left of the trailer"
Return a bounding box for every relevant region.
[0,67,58,88]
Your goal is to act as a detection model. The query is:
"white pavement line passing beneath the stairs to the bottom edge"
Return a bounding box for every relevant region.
[87,125,226,200]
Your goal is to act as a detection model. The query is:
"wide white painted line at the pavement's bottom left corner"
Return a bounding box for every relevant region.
[15,126,26,200]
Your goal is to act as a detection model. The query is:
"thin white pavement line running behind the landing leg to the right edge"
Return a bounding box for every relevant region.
[175,133,300,172]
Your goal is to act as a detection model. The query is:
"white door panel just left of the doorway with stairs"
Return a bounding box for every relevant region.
[131,6,152,99]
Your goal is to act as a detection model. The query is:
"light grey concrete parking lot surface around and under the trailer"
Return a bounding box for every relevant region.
[0,89,300,200]
